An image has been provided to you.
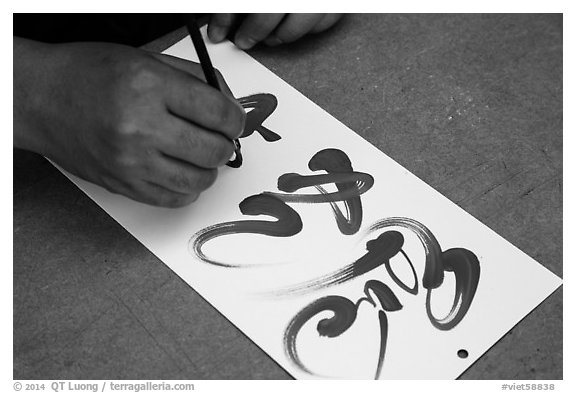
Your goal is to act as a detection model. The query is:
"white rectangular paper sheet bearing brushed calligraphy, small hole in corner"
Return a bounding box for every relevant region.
[55,34,561,379]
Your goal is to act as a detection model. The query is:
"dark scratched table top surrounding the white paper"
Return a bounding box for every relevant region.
[13,14,563,379]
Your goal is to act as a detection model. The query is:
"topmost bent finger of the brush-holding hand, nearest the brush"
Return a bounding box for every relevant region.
[164,61,246,139]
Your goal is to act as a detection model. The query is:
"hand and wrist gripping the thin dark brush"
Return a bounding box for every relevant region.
[14,38,246,207]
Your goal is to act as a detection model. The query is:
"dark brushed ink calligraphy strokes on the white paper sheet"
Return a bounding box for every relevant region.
[189,136,480,378]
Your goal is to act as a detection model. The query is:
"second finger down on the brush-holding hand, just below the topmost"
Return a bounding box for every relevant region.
[156,117,234,169]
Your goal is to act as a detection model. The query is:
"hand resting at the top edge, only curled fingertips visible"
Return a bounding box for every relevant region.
[208,14,342,50]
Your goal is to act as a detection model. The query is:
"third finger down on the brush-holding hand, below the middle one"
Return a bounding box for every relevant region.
[145,156,218,194]
